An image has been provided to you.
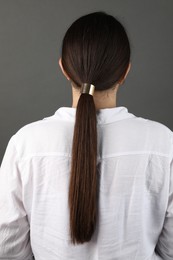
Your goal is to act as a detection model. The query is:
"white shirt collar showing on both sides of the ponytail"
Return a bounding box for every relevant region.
[54,106,135,125]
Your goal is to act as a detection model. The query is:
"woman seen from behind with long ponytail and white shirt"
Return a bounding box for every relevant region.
[0,12,173,260]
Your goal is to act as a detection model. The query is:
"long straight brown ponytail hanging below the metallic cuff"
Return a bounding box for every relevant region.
[68,93,98,244]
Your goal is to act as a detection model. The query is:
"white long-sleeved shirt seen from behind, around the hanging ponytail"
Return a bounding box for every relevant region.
[0,107,173,260]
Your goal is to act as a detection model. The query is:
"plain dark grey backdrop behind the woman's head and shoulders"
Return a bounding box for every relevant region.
[0,0,173,161]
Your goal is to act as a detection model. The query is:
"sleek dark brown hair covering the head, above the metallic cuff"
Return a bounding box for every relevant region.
[62,12,130,91]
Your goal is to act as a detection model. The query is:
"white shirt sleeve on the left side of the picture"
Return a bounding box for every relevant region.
[0,136,33,260]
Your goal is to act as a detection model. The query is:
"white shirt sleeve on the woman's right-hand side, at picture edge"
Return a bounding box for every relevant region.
[156,135,173,260]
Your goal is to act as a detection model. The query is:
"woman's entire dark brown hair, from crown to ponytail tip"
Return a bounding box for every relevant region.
[62,12,130,244]
